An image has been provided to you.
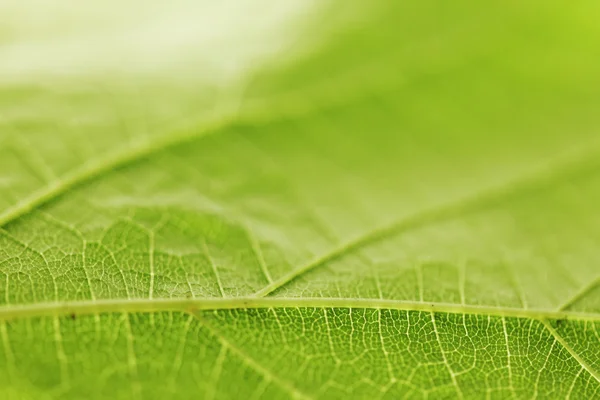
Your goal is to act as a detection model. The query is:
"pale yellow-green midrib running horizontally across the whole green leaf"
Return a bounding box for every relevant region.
[0,297,600,322]
